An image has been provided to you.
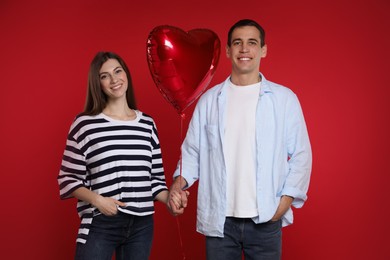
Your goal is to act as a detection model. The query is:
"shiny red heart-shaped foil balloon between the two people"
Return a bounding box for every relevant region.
[147,25,221,114]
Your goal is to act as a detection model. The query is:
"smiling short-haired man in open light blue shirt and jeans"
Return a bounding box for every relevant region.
[170,19,312,260]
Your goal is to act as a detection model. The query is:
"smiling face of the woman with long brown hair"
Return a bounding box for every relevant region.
[99,59,128,100]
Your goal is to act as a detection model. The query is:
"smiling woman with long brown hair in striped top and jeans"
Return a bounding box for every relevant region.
[58,52,168,260]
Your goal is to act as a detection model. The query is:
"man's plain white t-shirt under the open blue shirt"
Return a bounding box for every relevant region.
[224,79,260,218]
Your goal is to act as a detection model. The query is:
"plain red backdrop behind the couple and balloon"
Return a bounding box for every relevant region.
[0,0,390,260]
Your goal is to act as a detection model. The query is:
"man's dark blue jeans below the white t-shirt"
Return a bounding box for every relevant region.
[206,217,282,260]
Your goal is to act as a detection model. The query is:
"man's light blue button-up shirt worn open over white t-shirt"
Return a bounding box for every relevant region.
[174,75,312,237]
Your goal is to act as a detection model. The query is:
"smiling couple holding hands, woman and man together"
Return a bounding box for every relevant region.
[58,19,312,260]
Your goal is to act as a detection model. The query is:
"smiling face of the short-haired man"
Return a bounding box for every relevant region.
[226,26,267,74]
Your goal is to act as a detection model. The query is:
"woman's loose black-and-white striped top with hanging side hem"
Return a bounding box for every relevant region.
[58,111,167,243]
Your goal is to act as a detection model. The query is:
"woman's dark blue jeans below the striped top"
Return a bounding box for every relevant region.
[75,212,154,260]
